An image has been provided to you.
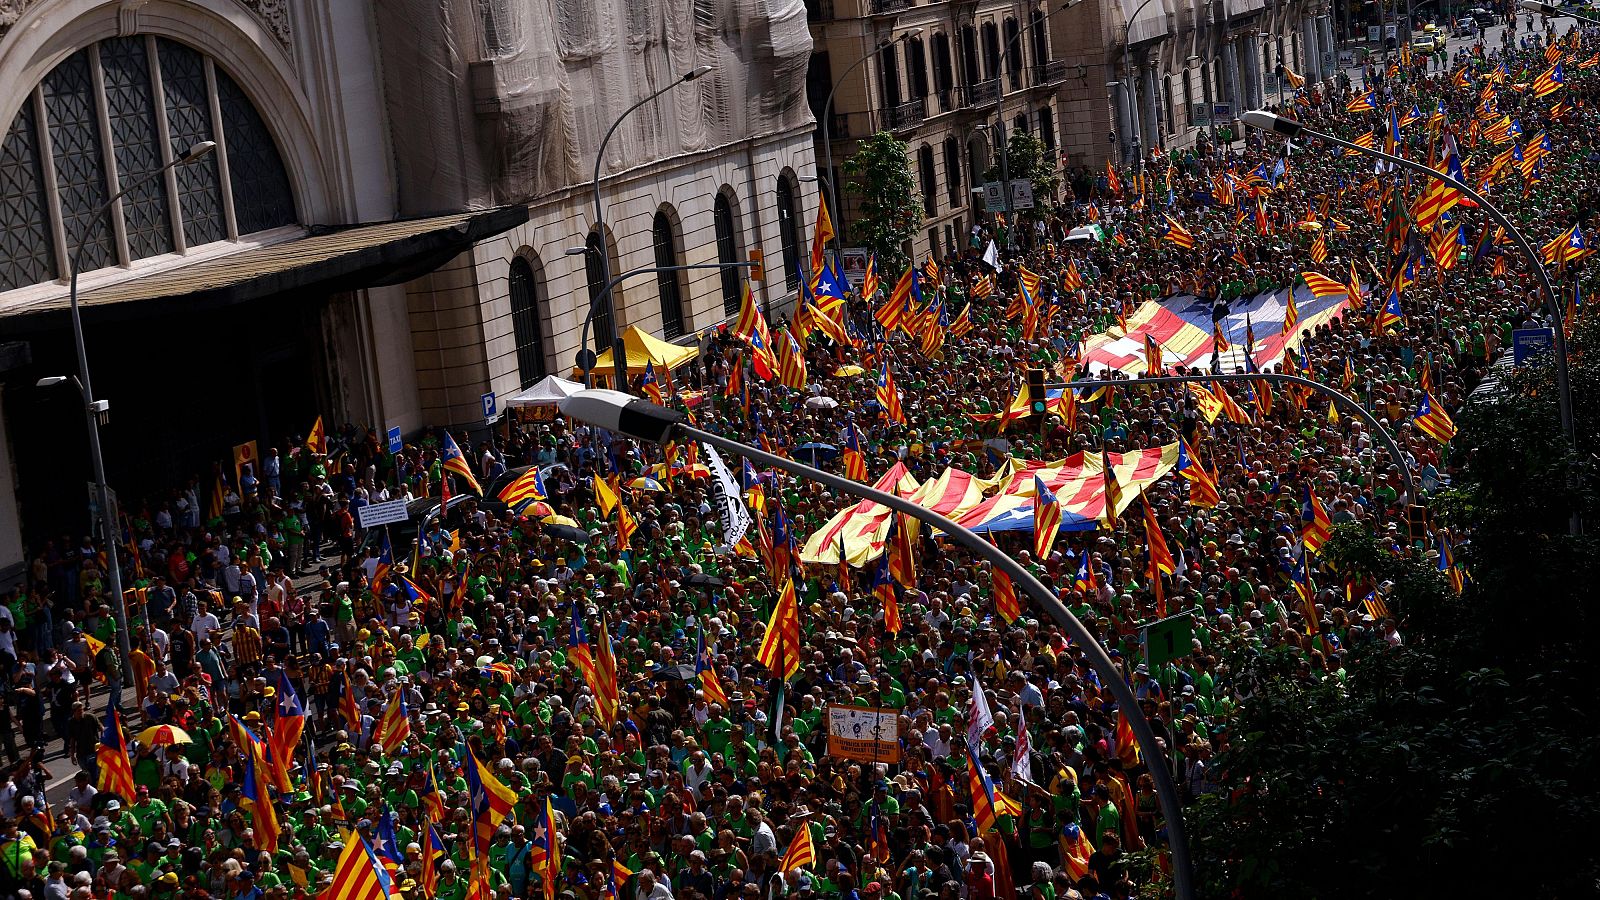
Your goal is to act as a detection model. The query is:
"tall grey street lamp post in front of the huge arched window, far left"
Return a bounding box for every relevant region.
[54,141,216,708]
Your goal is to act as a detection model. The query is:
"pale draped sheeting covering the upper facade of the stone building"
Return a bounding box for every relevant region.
[374,0,811,215]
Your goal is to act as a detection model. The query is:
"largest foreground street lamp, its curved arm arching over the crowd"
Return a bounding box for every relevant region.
[560,391,1195,900]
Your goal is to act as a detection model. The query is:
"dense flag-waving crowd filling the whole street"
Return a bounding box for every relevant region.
[0,10,1600,900]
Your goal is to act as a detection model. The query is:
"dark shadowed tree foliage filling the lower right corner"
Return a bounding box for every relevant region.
[1190,317,1600,900]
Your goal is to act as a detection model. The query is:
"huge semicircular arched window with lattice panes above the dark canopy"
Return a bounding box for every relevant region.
[0,35,296,291]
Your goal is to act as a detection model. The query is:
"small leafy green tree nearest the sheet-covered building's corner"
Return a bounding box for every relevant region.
[845,131,922,273]
